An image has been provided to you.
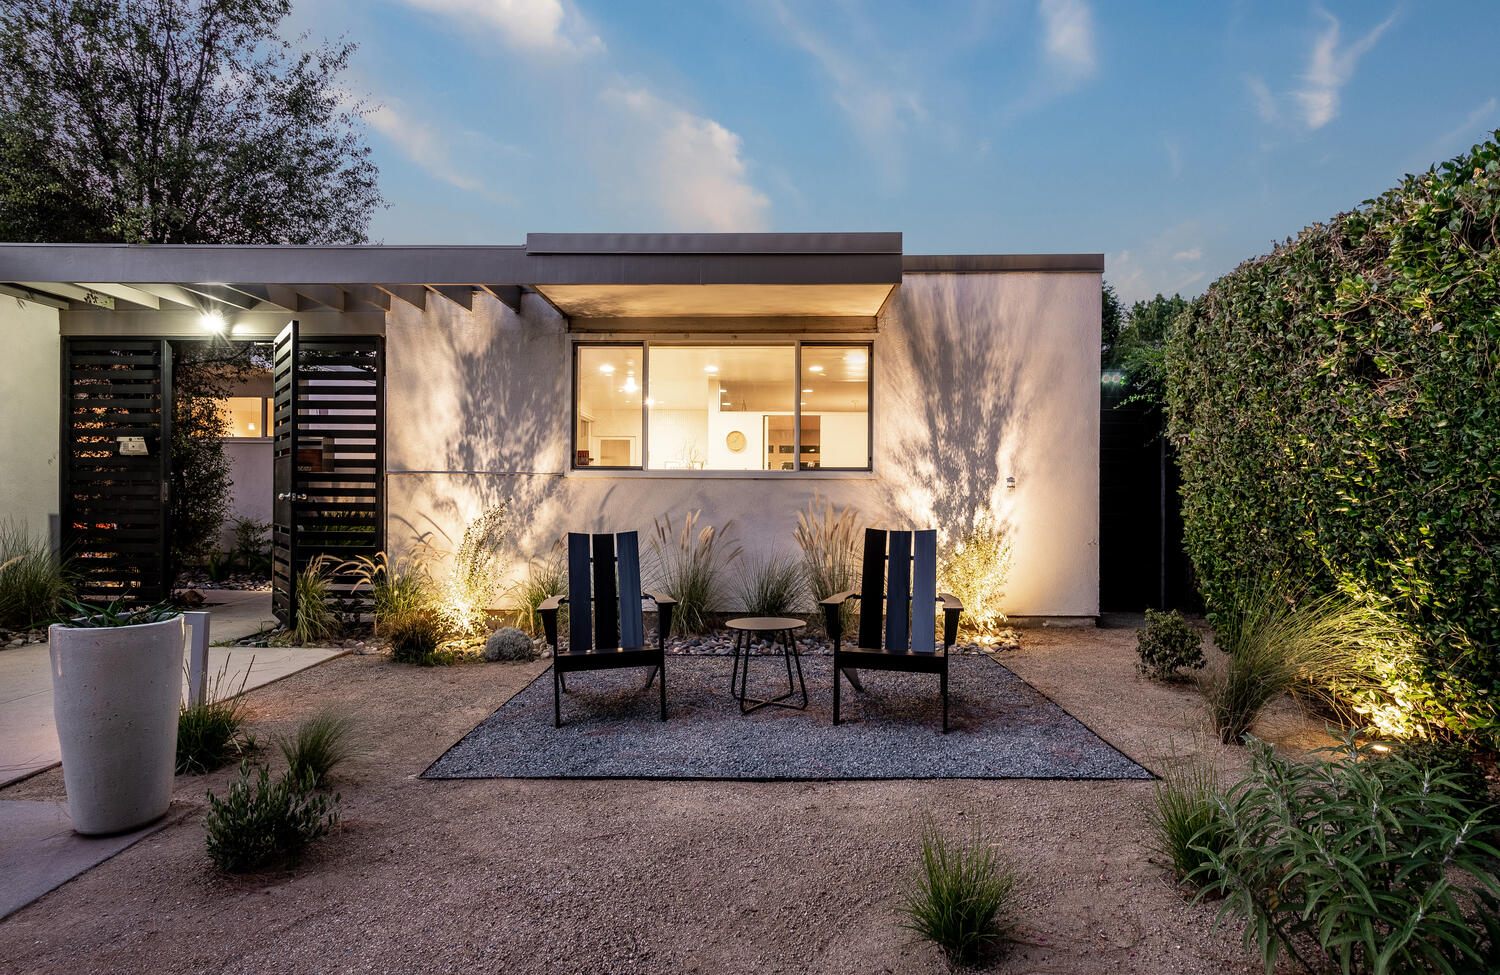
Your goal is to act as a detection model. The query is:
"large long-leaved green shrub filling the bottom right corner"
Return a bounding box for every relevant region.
[1199,734,1500,972]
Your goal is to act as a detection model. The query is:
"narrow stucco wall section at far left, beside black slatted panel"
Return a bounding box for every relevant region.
[0,296,62,539]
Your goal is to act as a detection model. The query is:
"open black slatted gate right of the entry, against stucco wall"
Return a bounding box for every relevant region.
[272,323,386,623]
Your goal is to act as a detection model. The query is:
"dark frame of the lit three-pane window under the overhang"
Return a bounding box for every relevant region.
[567,333,876,480]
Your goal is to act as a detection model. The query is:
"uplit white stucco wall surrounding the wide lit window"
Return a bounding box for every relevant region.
[387,273,1100,617]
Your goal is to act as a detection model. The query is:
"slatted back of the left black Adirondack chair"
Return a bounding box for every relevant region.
[567,531,645,651]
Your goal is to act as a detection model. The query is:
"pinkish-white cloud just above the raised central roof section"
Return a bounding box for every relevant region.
[603,87,771,233]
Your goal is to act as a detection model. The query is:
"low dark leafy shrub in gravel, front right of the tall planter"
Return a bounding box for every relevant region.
[206,762,339,873]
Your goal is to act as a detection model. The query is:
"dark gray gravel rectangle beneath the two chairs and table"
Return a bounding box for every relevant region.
[423,656,1151,780]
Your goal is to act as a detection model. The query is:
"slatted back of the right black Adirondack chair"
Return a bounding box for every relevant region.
[858,528,938,653]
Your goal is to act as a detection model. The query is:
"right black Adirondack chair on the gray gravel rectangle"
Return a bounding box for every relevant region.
[822,528,963,735]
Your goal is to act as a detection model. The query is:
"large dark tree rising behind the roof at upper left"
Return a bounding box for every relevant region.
[0,0,381,243]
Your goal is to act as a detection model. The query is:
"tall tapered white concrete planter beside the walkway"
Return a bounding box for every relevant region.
[50,615,186,834]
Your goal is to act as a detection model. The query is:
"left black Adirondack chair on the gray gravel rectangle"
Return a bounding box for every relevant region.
[539,531,677,728]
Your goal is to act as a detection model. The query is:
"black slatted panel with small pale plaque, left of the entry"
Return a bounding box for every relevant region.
[62,339,173,603]
